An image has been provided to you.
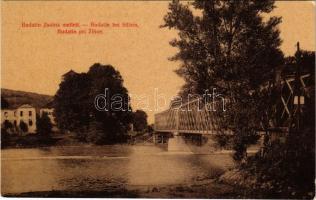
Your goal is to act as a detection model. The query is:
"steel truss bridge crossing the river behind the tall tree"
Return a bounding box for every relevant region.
[154,74,311,143]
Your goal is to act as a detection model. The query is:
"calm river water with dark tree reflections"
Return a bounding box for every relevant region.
[1,145,232,194]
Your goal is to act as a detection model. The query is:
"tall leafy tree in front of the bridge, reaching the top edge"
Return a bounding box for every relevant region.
[162,0,283,160]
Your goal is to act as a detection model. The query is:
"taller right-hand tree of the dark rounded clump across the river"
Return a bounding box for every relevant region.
[87,64,132,143]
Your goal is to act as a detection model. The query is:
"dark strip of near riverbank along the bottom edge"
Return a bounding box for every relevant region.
[2,179,243,198]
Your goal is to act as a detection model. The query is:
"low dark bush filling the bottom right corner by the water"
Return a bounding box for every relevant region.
[242,130,315,198]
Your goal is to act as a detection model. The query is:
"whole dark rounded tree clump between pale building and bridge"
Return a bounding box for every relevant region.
[54,63,132,144]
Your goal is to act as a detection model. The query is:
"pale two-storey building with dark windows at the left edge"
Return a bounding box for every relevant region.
[1,104,36,133]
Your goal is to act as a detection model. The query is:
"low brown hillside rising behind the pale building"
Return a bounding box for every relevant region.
[1,88,53,109]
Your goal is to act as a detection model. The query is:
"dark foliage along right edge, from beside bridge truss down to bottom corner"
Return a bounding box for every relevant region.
[245,51,315,199]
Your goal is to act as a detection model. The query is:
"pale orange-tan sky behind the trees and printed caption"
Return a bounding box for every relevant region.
[1,1,315,122]
